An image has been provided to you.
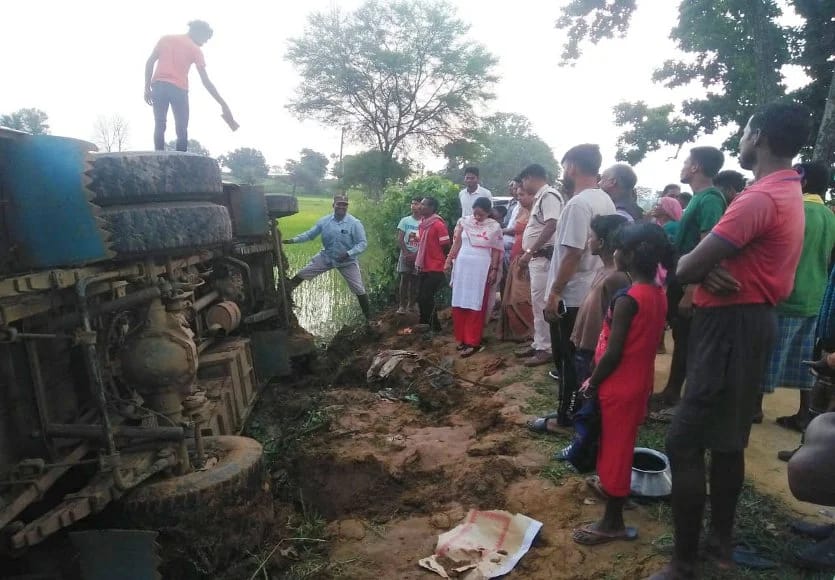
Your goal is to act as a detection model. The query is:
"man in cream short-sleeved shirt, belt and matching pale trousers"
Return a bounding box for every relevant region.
[516,163,563,367]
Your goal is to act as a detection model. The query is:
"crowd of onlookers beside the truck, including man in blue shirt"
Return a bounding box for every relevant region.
[286,103,835,580]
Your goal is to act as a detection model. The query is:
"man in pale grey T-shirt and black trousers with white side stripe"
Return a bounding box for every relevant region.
[545,144,616,429]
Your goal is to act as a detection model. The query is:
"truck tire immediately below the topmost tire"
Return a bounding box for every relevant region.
[100,201,232,257]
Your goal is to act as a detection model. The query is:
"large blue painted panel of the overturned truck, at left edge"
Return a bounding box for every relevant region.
[0,135,107,268]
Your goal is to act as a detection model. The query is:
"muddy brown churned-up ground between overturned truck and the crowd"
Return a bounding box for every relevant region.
[240,317,828,580]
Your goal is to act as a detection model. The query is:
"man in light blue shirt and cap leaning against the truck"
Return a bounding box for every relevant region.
[284,195,370,319]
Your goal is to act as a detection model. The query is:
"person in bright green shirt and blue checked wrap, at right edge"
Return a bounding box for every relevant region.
[757,161,835,431]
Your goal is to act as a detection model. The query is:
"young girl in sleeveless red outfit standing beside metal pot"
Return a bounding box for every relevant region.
[573,224,673,545]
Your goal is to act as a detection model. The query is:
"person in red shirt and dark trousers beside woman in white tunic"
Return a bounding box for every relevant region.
[415,197,450,332]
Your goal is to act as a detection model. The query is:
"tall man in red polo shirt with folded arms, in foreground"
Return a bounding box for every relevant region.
[652,103,810,580]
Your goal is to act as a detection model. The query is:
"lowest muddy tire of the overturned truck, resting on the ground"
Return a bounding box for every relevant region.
[119,435,274,578]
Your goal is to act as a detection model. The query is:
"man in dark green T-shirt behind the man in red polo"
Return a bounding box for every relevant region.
[654,147,727,418]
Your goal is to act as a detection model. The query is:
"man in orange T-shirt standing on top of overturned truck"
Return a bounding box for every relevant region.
[145,20,237,151]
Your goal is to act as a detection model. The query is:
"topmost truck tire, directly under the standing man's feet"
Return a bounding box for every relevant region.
[86,151,223,206]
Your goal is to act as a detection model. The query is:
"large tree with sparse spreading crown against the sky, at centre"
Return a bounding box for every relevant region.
[286,0,497,190]
